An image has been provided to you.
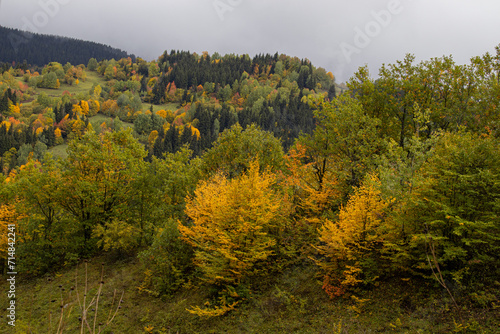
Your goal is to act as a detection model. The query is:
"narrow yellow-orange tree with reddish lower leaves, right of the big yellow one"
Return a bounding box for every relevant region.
[316,175,393,296]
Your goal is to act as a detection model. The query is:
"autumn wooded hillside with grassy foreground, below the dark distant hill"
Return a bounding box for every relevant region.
[0,36,500,333]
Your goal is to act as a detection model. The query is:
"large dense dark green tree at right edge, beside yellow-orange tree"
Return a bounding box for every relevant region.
[402,133,500,288]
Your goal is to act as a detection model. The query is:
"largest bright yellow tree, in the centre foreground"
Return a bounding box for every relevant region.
[179,161,286,287]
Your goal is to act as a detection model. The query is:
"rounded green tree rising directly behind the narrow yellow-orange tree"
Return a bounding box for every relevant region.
[299,95,383,204]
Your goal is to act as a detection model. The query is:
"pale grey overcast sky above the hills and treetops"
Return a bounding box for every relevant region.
[0,0,500,83]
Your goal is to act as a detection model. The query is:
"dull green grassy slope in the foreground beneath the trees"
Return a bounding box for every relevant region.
[0,257,500,334]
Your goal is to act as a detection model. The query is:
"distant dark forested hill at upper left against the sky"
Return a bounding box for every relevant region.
[0,27,135,66]
